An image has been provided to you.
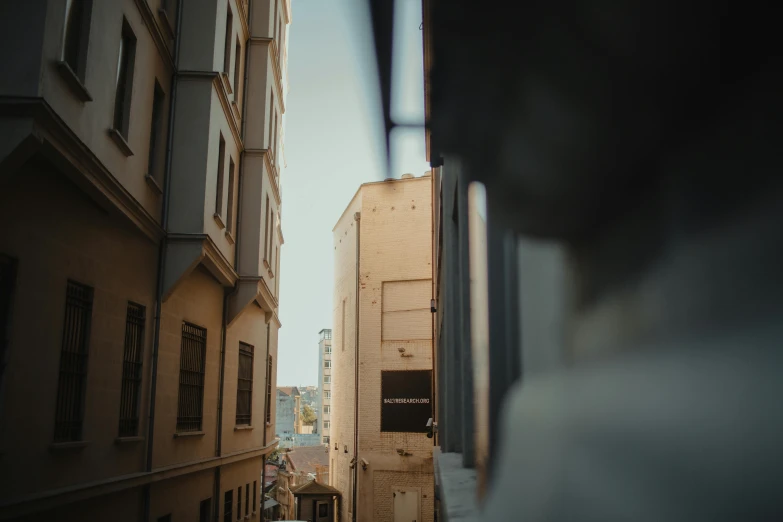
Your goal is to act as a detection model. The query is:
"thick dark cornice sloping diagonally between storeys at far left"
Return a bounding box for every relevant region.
[0,97,164,242]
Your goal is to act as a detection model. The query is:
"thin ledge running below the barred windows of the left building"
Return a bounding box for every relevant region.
[0,441,277,520]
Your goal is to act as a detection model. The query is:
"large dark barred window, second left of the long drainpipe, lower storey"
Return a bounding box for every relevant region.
[54,281,93,442]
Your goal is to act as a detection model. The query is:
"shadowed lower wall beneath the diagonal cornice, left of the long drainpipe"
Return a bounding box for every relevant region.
[0,158,157,498]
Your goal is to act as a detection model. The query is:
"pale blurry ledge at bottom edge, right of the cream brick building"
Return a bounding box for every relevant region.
[432,447,479,522]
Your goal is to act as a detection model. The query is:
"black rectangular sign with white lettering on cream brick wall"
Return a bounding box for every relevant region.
[381,370,432,433]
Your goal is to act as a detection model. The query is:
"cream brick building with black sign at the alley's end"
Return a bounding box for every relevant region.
[329,174,435,522]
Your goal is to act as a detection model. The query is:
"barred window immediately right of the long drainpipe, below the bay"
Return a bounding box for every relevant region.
[177,322,207,431]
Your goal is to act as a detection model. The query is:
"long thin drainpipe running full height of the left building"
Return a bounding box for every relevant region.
[144,0,184,521]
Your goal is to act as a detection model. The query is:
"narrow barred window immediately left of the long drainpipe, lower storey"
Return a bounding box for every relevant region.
[119,303,145,437]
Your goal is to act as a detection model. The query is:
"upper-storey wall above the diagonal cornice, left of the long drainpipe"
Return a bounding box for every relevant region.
[41,0,172,219]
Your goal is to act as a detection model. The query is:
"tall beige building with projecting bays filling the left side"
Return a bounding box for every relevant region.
[0,0,291,522]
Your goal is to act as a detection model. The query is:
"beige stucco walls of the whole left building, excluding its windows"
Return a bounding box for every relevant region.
[0,0,283,520]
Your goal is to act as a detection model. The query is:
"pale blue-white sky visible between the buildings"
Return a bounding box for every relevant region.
[277,0,429,386]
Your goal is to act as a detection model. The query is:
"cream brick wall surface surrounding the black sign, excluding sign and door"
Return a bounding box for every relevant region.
[331,178,434,522]
